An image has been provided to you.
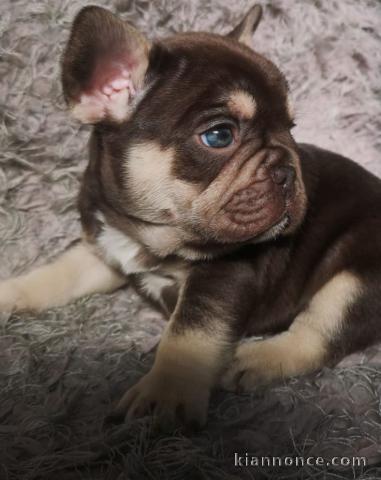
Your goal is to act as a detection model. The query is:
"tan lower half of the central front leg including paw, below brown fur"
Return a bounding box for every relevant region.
[117,322,230,425]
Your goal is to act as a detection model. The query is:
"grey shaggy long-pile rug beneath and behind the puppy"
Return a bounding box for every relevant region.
[0,0,381,480]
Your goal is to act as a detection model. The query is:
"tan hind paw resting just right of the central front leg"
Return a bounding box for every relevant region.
[220,340,285,392]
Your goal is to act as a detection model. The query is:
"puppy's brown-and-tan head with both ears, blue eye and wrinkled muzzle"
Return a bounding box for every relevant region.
[62,6,306,255]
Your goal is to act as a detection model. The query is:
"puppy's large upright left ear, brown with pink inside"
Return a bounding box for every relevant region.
[62,6,149,123]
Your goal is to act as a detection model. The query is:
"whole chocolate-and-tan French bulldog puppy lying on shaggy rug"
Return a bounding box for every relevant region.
[0,6,381,424]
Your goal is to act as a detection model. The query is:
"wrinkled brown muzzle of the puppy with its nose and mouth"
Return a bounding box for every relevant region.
[192,147,305,243]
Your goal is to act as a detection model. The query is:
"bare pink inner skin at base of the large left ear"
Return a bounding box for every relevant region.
[73,61,136,123]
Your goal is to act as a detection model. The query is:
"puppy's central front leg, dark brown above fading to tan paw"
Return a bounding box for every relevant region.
[116,264,252,426]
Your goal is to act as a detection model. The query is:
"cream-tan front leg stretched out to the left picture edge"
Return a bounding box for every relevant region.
[0,242,126,311]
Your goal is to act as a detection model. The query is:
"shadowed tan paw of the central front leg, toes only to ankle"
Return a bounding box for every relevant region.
[116,369,210,429]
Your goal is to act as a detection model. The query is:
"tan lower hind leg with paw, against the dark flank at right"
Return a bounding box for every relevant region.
[222,272,361,390]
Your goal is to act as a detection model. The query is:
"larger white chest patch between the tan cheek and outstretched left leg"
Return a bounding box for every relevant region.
[97,214,149,275]
